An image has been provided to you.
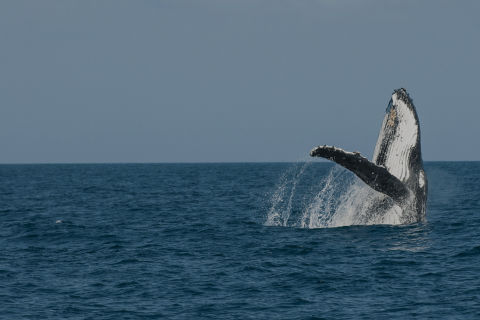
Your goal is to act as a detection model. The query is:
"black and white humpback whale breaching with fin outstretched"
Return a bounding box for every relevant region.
[310,88,427,223]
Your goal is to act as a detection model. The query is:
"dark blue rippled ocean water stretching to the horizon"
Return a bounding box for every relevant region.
[0,162,480,319]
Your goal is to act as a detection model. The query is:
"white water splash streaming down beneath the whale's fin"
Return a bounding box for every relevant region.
[265,162,402,229]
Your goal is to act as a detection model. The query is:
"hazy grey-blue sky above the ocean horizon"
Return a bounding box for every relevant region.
[0,0,480,163]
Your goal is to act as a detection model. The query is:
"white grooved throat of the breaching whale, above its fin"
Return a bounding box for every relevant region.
[373,93,418,181]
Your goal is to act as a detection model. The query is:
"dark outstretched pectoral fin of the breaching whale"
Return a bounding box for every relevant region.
[310,146,410,203]
